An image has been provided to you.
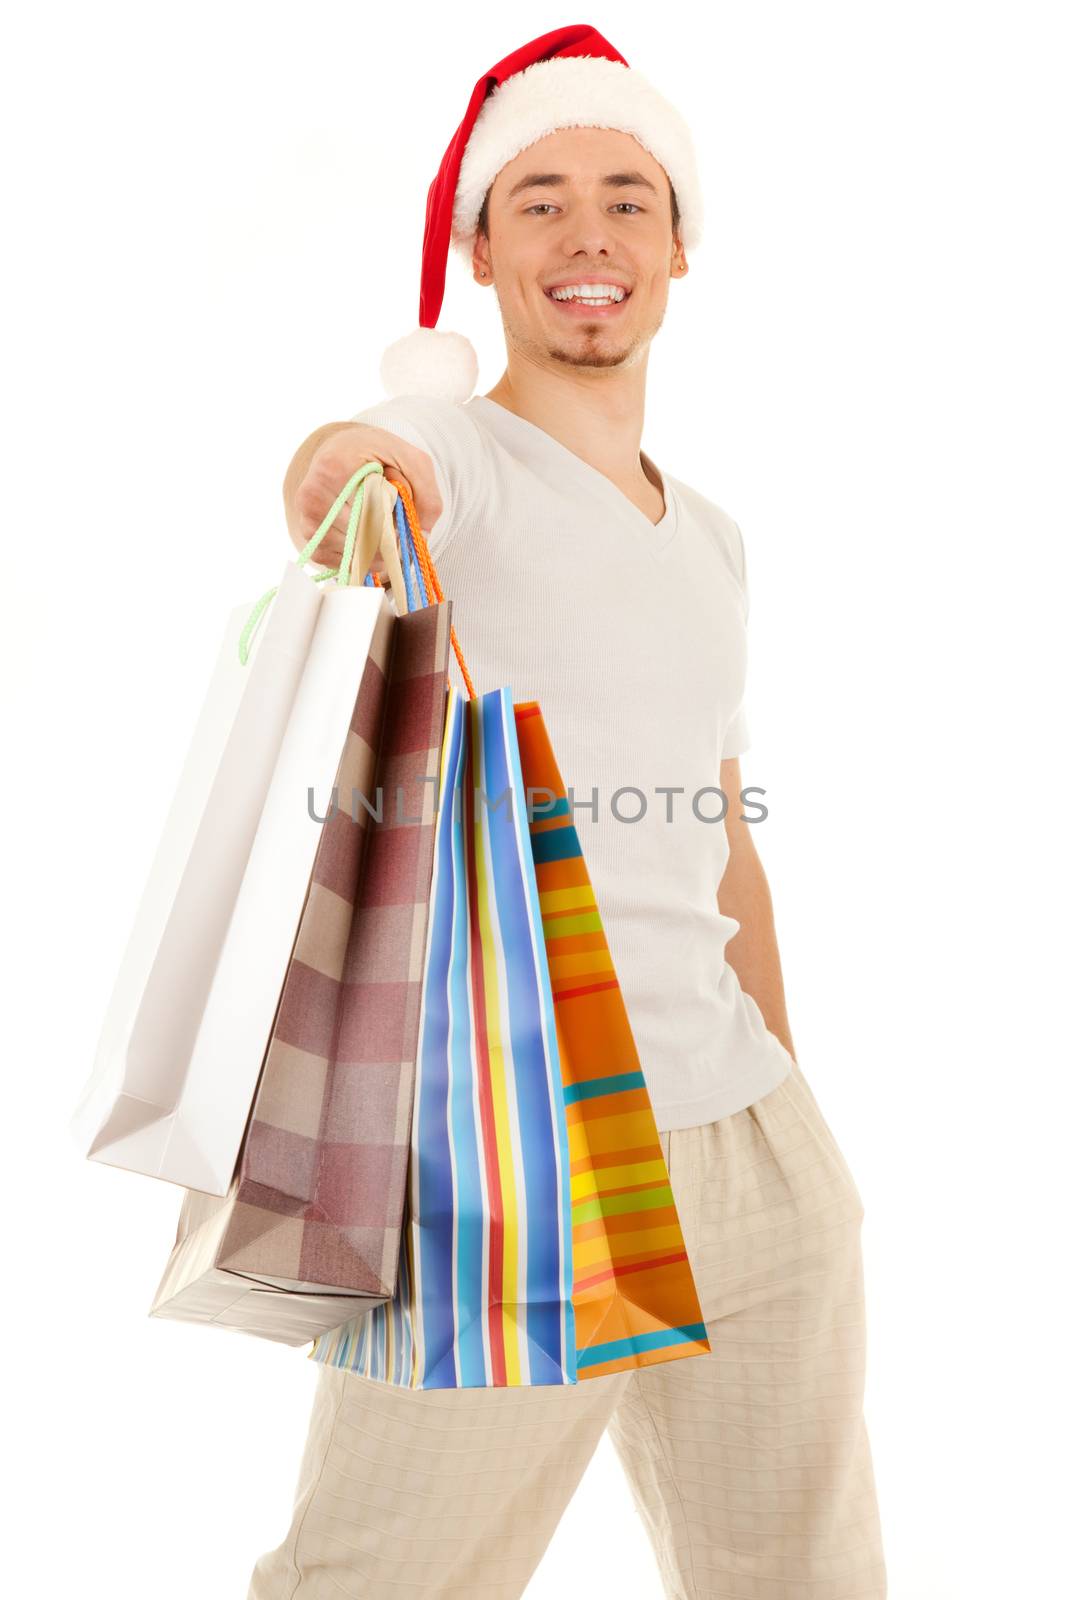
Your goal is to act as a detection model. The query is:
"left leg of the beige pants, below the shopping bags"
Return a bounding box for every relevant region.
[248,1366,632,1600]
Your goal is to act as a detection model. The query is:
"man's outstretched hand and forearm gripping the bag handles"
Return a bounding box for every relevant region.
[282,422,442,571]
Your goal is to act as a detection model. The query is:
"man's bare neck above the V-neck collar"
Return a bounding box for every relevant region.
[486,365,664,522]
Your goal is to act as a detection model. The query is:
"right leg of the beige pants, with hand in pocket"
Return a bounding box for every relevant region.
[608,1069,885,1600]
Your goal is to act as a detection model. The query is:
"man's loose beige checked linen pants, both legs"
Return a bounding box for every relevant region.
[248,1066,886,1600]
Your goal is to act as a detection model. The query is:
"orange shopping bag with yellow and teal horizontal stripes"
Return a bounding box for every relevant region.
[515,701,710,1378]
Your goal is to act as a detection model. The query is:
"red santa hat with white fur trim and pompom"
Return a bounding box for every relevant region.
[381,24,704,402]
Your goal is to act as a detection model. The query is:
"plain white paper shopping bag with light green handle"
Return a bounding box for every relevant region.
[70,462,406,1195]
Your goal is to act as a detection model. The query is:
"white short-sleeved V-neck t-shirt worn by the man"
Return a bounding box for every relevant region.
[352,395,792,1130]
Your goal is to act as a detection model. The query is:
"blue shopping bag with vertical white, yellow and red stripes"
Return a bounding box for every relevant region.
[310,675,577,1389]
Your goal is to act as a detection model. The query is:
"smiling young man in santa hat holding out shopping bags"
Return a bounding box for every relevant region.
[248,27,886,1600]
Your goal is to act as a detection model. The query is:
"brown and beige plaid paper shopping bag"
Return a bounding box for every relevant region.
[149,508,451,1344]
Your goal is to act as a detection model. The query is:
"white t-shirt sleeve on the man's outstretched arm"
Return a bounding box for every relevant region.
[350,395,486,560]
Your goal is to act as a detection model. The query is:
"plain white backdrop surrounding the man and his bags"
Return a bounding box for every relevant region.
[0,0,1067,1600]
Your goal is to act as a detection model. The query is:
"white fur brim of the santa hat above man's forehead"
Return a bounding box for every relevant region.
[451,56,704,261]
